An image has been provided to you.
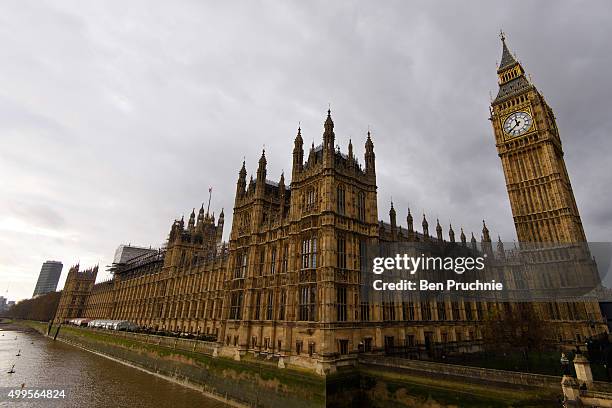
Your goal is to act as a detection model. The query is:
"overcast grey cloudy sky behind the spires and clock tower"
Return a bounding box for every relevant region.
[0,0,612,299]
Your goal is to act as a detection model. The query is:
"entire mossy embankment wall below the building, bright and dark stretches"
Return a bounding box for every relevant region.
[21,322,561,408]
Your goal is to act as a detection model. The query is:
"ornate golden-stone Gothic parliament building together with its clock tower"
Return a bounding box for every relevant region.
[56,36,607,373]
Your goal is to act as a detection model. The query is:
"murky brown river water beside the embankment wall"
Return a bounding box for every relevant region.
[0,325,228,408]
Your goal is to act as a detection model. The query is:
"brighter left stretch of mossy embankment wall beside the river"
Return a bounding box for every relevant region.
[21,321,325,408]
